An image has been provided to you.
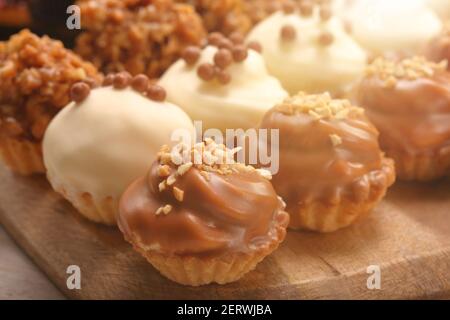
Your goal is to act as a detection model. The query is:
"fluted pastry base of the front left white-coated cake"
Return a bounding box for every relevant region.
[47,172,119,226]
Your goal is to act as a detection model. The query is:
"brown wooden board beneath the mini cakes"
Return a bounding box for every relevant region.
[0,167,450,299]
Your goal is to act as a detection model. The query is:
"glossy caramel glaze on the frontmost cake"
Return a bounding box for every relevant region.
[118,162,289,256]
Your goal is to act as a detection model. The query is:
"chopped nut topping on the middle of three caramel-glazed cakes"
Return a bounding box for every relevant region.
[276,92,364,120]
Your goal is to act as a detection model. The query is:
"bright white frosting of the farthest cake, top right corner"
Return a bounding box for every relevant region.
[344,0,442,54]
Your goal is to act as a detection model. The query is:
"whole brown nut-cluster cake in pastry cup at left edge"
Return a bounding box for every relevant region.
[0,30,102,175]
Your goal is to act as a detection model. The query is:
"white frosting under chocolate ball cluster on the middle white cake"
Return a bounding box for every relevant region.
[160,46,287,131]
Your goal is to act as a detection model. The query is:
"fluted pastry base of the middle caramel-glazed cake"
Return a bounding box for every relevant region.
[287,159,395,232]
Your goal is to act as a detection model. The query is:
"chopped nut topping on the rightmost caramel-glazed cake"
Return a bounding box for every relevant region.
[366,56,447,87]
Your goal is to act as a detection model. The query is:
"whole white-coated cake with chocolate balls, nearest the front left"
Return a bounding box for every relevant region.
[43,73,194,225]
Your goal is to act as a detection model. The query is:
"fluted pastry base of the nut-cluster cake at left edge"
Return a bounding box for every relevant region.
[0,138,45,176]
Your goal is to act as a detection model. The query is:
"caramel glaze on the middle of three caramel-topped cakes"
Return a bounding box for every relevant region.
[261,100,393,212]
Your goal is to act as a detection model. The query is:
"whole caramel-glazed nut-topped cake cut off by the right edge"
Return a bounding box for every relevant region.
[357,57,450,181]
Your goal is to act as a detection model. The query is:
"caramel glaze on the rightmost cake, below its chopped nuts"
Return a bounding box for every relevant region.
[357,71,450,156]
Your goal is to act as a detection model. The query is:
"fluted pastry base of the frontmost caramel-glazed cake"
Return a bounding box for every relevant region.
[126,212,289,286]
